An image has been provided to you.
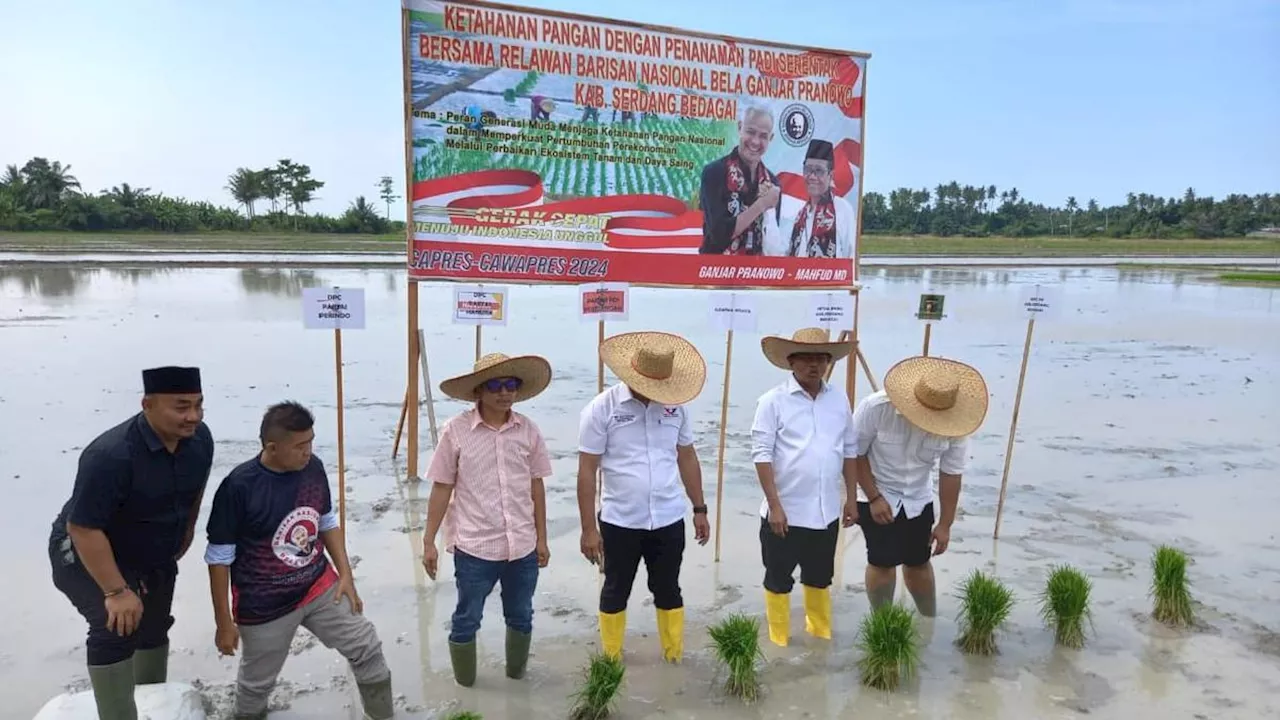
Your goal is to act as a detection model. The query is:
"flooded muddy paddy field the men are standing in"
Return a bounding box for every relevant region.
[0,263,1280,720]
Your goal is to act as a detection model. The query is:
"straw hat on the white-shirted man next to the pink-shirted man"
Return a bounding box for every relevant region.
[600,332,707,405]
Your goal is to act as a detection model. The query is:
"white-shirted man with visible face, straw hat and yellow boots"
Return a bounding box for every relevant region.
[751,328,858,647]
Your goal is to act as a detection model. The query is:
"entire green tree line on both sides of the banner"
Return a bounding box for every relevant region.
[0,158,1280,238]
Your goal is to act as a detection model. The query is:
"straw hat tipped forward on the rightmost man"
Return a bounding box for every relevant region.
[884,356,988,437]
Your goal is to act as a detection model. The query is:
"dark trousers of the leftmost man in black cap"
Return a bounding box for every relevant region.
[49,527,178,665]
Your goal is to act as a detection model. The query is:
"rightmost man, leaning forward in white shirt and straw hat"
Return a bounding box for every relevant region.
[854,357,988,609]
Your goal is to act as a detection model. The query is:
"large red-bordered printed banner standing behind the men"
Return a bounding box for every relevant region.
[404,0,867,288]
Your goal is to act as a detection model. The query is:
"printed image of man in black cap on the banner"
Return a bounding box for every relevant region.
[782,140,858,258]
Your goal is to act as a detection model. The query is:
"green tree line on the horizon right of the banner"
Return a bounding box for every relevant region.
[863,182,1280,238]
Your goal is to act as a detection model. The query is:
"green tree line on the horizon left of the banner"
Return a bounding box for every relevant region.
[0,158,404,234]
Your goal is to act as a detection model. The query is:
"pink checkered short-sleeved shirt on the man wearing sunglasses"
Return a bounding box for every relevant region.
[426,409,552,561]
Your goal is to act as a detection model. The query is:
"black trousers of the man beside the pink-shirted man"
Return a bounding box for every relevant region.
[600,520,685,615]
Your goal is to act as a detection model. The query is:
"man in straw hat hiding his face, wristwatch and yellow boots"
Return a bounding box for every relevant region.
[577,332,710,662]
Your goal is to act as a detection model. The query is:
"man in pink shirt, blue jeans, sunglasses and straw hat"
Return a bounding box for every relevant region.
[422,352,552,687]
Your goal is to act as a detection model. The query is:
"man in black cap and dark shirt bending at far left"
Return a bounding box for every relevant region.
[49,366,214,720]
